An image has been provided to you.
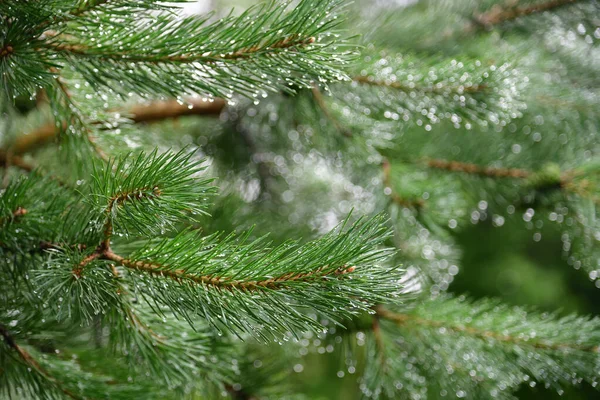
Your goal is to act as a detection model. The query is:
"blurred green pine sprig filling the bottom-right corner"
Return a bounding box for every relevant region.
[358,296,600,399]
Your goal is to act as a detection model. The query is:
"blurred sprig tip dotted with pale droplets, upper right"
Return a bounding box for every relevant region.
[332,52,527,128]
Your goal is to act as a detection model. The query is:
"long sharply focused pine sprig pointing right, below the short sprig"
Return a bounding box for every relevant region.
[103,218,400,339]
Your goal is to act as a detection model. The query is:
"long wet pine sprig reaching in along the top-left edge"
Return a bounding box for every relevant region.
[0,0,350,98]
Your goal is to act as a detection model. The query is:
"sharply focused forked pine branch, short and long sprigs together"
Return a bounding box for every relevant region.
[0,152,400,339]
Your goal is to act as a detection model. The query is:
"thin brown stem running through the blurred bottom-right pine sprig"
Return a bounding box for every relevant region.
[375,306,598,353]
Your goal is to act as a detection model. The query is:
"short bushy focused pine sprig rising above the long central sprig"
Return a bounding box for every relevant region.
[90,151,214,241]
